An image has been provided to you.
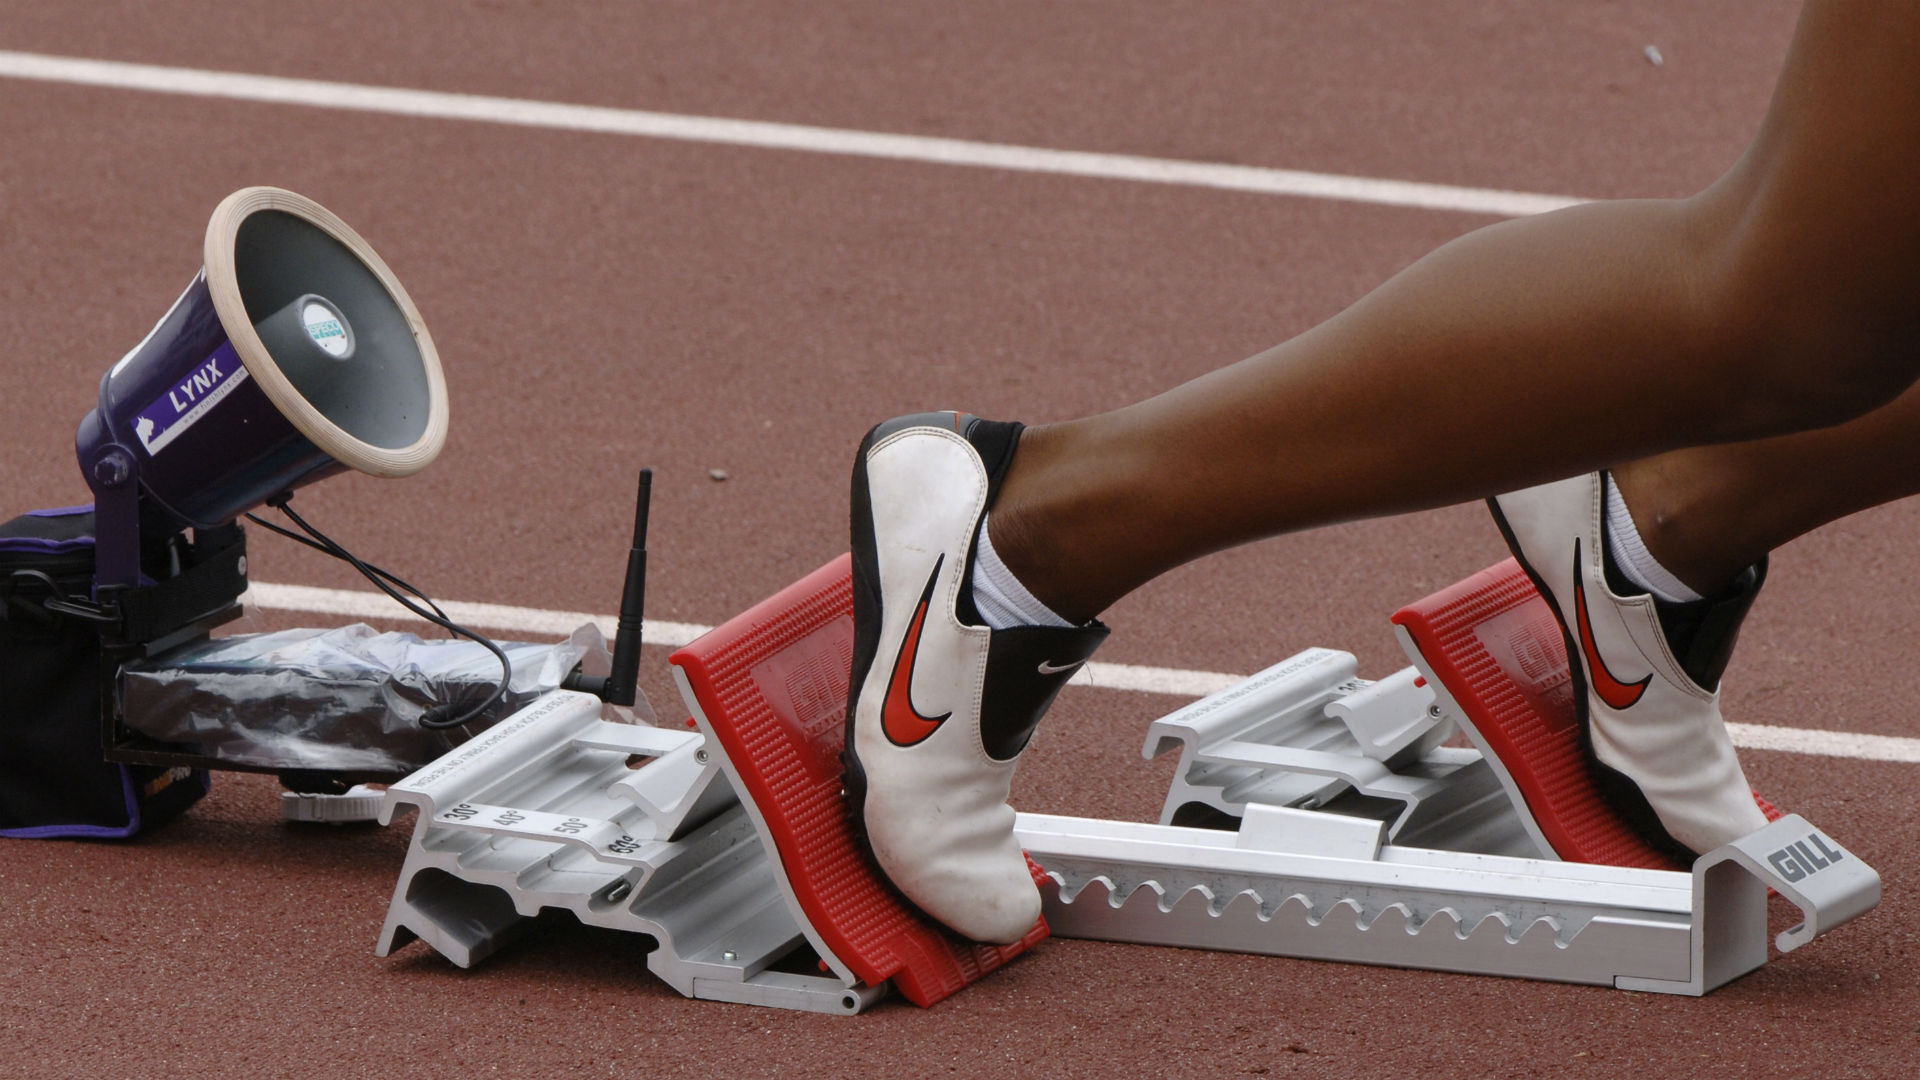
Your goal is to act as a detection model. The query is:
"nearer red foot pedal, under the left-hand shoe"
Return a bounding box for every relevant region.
[670,555,1046,1007]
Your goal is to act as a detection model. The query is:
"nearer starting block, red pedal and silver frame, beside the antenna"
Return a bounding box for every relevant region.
[378,555,1046,1013]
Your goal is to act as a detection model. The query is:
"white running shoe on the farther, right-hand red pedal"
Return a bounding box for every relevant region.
[1488,473,1766,855]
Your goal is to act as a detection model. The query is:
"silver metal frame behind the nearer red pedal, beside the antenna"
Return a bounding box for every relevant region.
[376,690,879,1013]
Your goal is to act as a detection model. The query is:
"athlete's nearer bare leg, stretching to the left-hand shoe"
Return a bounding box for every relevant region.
[991,0,1920,619]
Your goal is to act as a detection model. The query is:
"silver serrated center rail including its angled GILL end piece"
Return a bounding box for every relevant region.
[1016,805,1880,995]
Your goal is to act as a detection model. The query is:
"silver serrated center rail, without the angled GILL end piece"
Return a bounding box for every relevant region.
[1016,803,1692,986]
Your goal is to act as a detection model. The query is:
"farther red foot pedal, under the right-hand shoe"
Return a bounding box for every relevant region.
[1394,559,1780,871]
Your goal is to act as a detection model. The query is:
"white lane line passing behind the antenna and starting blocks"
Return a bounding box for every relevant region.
[244,582,1920,763]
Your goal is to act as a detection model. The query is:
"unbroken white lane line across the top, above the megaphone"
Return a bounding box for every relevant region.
[0,50,1584,217]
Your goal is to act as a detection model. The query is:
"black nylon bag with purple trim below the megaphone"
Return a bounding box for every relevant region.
[0,507,209,840]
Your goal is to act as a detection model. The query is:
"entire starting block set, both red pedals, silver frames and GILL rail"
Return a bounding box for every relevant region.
[378,557,1880,1013]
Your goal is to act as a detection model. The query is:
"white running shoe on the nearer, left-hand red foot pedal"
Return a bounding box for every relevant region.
[845,413,1106,944]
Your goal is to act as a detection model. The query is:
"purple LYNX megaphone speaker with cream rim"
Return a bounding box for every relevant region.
[75,188,447,588]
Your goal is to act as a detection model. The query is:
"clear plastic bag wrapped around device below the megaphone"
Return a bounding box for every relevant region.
[119,623,629,774]
